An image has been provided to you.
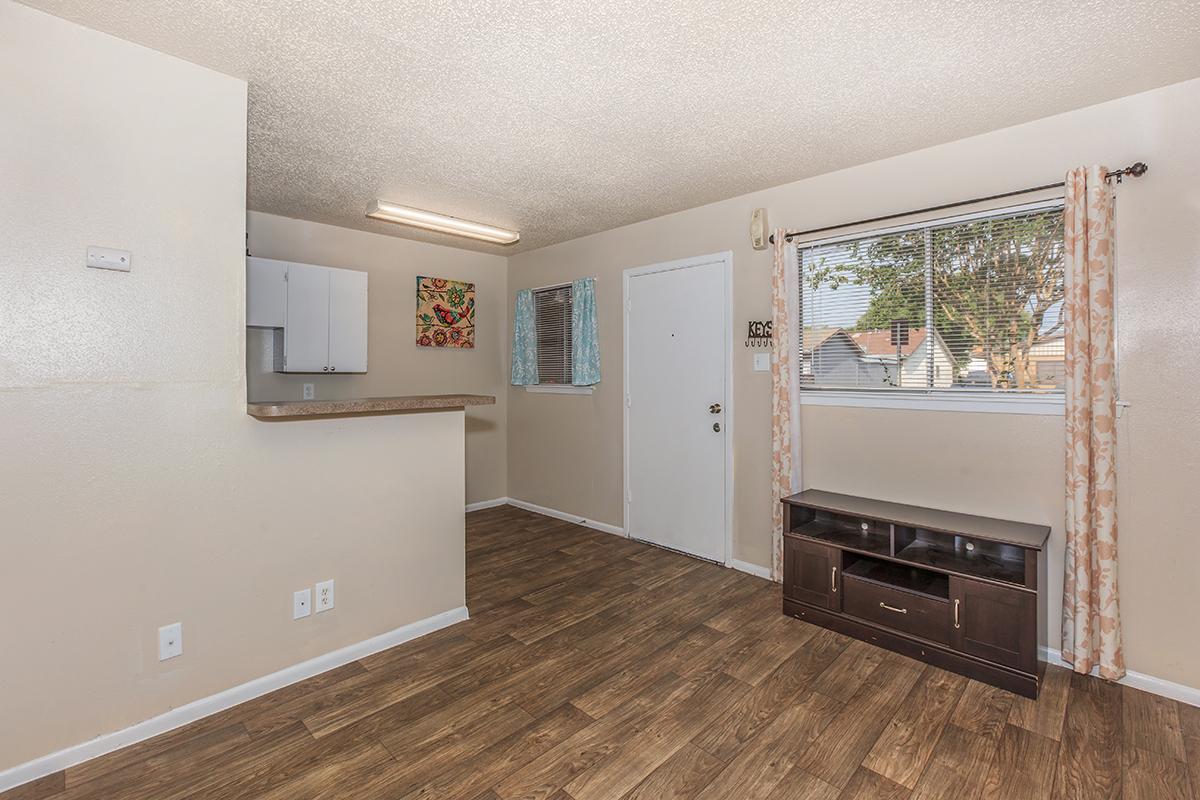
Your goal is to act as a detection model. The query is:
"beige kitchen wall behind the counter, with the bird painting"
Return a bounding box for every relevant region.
[246,212,509,503]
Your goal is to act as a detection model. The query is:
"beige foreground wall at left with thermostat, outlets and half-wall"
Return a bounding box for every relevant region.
[0,0,464,770]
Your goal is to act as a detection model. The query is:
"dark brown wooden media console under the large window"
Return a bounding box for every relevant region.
[782,489,1050,698]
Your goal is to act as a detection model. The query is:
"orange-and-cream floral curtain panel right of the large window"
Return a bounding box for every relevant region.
[1062,167,1126,680]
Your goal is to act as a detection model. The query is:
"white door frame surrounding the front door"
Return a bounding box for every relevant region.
[620,251,733,566]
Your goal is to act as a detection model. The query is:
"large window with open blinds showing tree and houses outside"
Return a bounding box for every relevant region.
[797,204,1066,397]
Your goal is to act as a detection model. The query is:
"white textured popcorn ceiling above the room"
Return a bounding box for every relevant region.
[16,0,1200,253]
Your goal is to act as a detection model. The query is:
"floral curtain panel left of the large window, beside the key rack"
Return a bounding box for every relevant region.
[770,229,802,582]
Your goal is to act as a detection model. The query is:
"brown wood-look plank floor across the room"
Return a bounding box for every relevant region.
[7,507,1200,800]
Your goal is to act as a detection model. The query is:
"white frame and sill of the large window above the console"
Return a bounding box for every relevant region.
[791,197,1067,416]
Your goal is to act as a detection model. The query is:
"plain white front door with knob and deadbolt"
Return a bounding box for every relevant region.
[625,253,732,564]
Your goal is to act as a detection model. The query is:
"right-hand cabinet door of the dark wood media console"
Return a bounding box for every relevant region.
[950,577,1038,673]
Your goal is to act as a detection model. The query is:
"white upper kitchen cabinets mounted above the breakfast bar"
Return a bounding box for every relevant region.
[246,258,367,373]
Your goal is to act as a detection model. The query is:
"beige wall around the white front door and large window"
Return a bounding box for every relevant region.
[509,80,1200,686]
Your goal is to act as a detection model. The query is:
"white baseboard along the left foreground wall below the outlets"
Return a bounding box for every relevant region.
[0,606,468,792]
